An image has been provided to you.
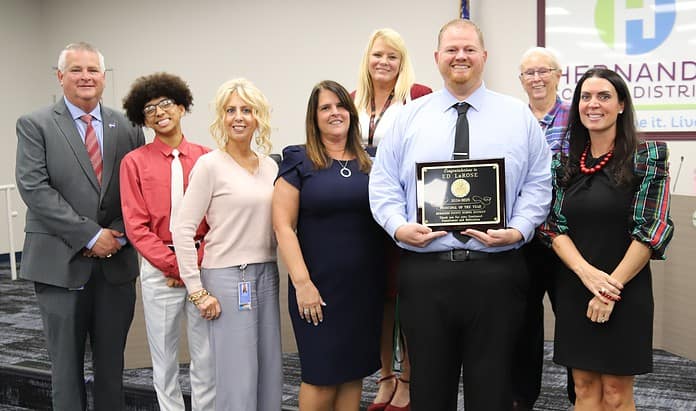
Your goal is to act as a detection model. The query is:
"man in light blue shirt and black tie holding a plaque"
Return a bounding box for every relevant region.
[369,19,551,411]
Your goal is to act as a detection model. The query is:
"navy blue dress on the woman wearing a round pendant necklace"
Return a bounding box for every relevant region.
[278,146,386,385]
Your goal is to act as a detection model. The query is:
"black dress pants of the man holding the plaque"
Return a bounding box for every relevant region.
[398,250,529,411]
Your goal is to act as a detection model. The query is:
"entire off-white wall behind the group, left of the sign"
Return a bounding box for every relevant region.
[0,0,536,253]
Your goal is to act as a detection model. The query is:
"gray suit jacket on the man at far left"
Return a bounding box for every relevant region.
[15,99,145,288]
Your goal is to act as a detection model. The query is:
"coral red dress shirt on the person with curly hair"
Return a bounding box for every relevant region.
[120,138,210,279]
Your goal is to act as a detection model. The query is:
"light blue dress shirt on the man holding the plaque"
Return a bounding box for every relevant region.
[369,85,551,252]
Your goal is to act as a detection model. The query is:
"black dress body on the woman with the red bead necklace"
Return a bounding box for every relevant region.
[553,159,653,375]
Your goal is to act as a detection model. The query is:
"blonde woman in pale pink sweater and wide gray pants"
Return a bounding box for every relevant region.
[173,79,282,411]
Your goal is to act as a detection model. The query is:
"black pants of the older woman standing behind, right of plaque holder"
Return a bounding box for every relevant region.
[512,237,575,410]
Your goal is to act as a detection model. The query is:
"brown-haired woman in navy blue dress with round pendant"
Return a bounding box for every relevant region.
[273,81,386,410]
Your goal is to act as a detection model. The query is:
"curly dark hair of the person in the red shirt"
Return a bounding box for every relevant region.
[123,72,193,126]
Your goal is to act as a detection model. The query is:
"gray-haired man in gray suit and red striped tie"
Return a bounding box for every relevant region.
[16,43,145,411]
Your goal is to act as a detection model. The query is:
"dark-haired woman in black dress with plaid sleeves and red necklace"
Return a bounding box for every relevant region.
[541,68,674,411]
